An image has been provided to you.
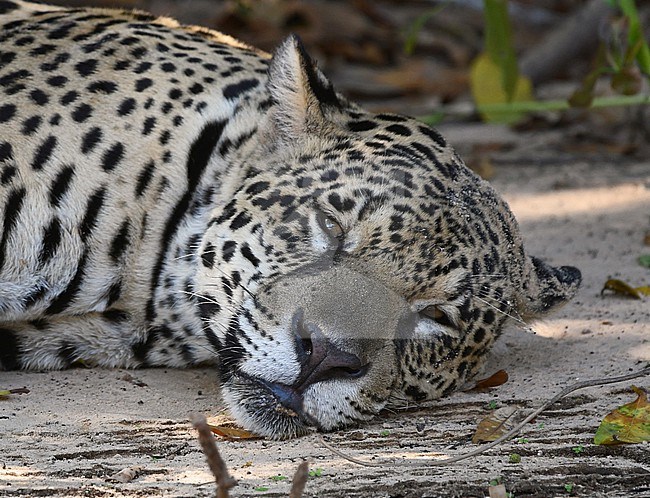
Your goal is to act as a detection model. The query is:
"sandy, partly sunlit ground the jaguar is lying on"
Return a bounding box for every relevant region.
[0,127,650,497]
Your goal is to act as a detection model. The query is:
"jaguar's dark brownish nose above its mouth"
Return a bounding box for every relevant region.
[292,310,370,392]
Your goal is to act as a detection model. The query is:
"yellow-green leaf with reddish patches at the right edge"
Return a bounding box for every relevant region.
[594,386,650,444]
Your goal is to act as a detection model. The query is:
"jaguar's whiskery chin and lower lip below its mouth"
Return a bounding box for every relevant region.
[222,374,321,439]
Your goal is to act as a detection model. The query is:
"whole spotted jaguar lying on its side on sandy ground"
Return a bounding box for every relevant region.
[0,0,581,439]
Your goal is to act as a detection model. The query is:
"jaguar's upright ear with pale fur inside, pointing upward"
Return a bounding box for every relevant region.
[268,35,341,143]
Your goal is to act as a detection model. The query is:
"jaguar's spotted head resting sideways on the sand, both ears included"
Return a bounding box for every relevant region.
[197,38,580,438]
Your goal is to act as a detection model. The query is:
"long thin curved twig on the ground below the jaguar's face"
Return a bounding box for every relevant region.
[319,367,650,467]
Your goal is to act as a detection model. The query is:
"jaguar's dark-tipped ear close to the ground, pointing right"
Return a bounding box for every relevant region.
[520,257,582,319]
